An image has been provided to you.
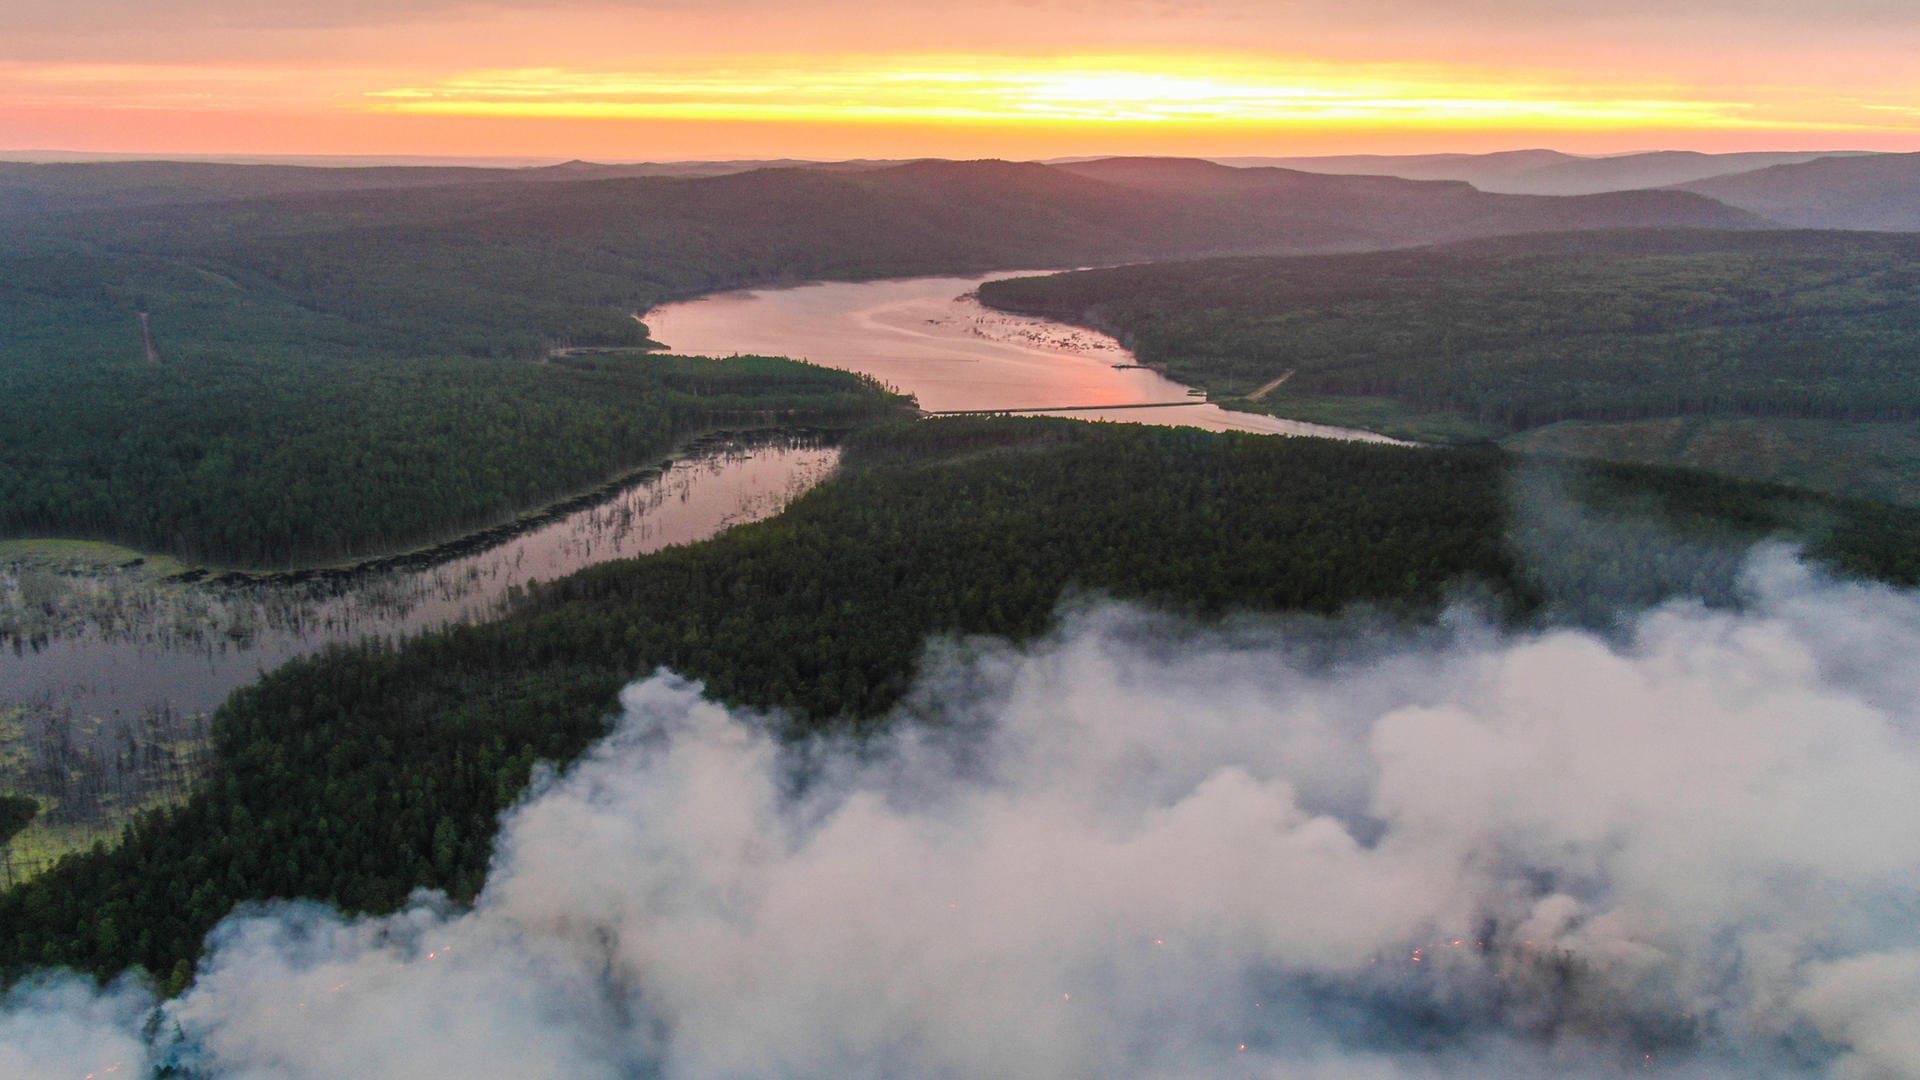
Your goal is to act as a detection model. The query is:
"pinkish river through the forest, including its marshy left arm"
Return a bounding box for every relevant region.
[0,269,1380,841]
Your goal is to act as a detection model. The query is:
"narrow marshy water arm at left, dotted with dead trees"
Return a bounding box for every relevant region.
[0,438,839,730]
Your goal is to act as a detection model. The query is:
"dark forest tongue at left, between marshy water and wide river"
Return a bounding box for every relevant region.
[0,345,897,567]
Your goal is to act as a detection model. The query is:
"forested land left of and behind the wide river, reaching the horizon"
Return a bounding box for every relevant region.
[0,161,1740,565]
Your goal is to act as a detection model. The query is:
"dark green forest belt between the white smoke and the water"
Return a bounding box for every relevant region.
[0,419,1920,990]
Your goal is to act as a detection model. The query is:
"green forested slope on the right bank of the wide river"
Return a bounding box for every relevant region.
[981,231,1920,465]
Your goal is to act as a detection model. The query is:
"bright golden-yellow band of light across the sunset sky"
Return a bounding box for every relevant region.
[365,56,1907,131]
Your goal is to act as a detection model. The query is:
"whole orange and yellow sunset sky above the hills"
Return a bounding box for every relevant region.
[0,0,1920,160]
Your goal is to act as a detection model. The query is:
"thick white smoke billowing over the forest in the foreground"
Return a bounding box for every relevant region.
[11,552,1920,1080]
